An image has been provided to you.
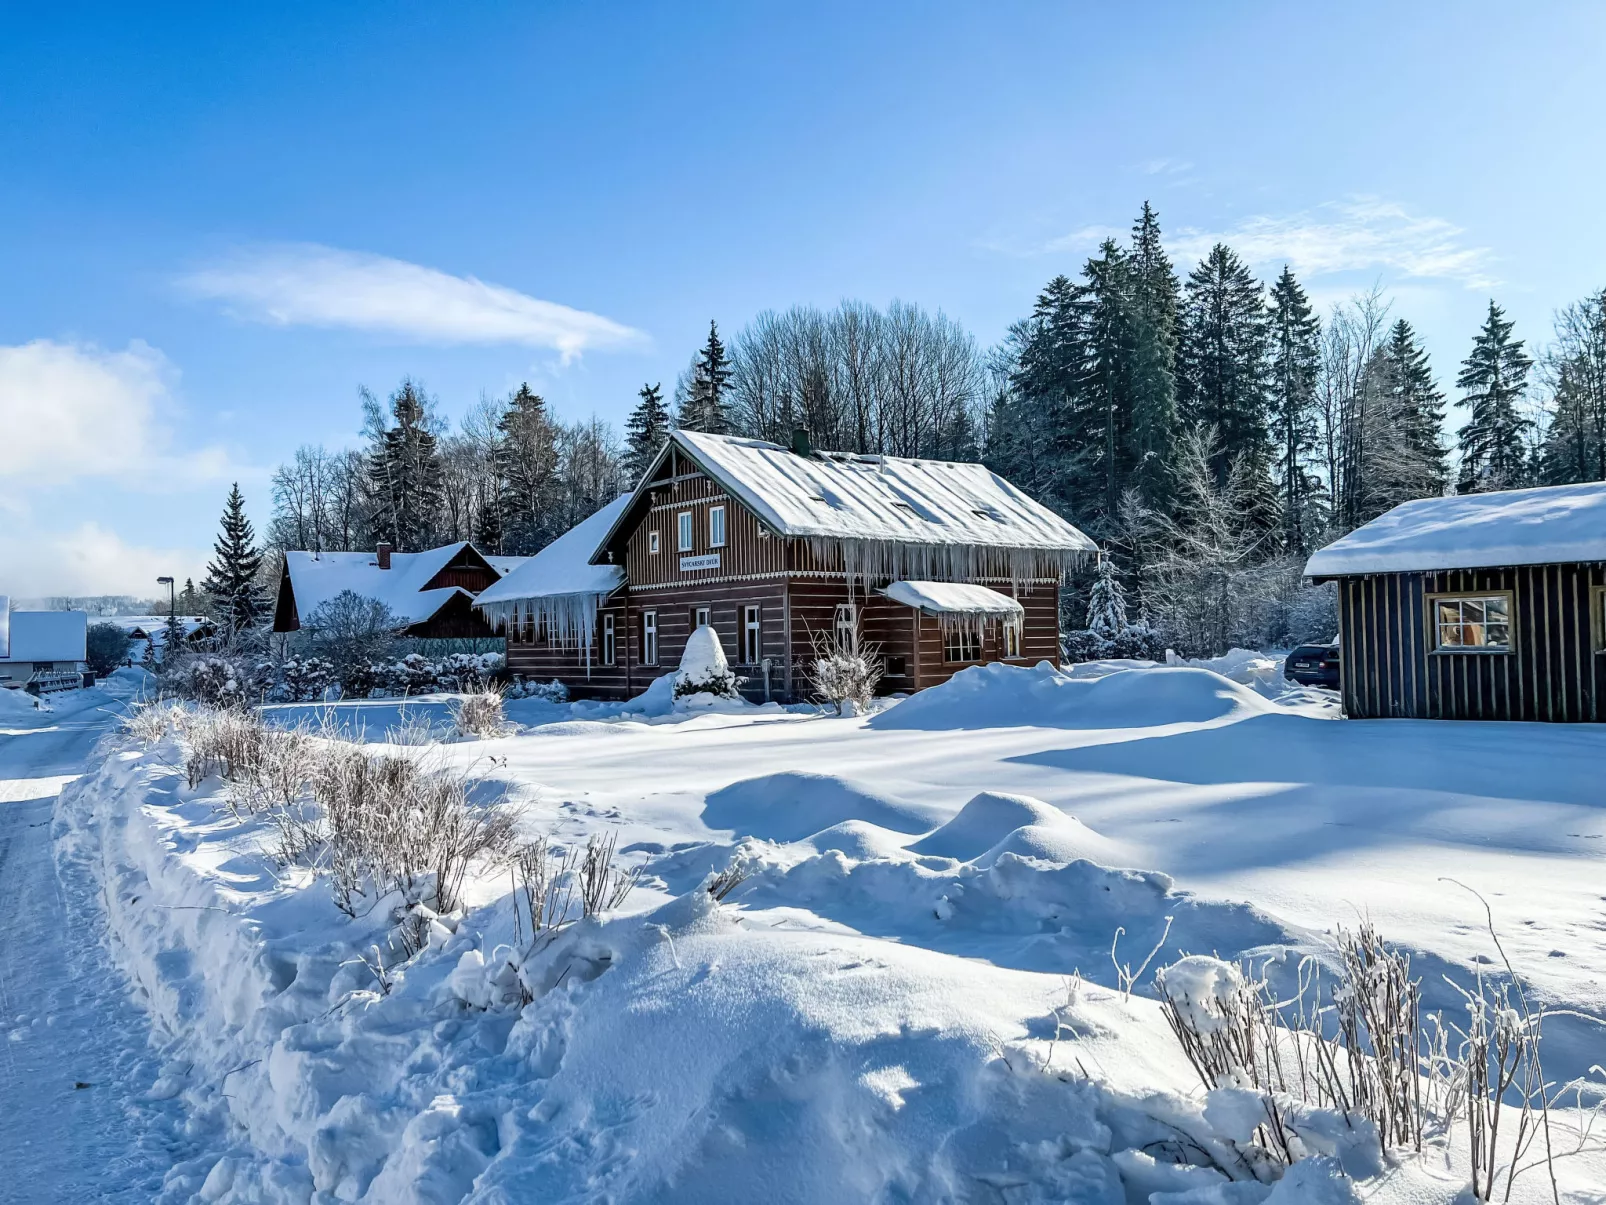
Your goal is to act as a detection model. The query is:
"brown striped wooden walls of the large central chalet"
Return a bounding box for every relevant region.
[507,445,1060,702]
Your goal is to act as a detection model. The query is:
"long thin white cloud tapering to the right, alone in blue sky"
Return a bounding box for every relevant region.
[180,244,644,360]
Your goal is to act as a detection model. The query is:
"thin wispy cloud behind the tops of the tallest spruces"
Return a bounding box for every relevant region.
[1042,198,1497,289]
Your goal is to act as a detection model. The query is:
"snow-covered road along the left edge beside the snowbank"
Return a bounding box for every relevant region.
[0,691,186,1202]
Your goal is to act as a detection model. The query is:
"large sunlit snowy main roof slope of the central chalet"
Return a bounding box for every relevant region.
[658,431,1097,554]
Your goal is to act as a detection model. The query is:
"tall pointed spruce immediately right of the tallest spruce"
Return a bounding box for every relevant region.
[1177,243,1270,485]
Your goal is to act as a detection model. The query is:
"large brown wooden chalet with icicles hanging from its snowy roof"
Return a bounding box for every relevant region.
[475,431,1097,701]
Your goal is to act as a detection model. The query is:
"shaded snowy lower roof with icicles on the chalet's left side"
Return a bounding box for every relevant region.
[474,493,630,647]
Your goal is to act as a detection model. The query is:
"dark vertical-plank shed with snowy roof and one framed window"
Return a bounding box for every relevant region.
[1306,482,1606,721]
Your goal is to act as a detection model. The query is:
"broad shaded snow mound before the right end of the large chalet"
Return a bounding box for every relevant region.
[869,662,1275,729]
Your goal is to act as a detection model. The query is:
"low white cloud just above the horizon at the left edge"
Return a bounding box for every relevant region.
[0,522,206,598]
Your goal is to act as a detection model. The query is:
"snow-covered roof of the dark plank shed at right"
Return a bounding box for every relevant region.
[1306,482,1606,577]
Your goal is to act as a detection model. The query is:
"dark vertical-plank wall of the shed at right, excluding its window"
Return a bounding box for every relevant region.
[1338,564,1606,723]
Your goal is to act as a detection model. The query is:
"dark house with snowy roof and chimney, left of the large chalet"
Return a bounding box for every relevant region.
[273,541,528,639]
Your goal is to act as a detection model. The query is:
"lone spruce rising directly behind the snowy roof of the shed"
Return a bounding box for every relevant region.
[1455,300,1534,493]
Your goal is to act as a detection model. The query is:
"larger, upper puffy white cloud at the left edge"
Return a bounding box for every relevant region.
[0,339,228,488]
